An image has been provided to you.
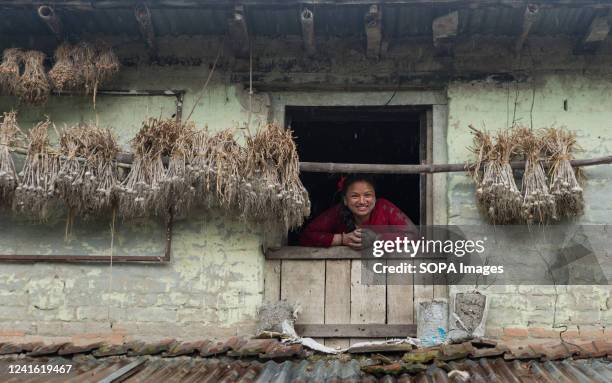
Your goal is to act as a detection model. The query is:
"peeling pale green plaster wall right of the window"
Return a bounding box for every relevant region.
[447,75,612,337]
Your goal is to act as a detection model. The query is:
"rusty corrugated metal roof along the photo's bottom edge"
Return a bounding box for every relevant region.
[0,357,612,383]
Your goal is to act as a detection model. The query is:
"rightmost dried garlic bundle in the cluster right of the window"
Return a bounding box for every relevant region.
[546,128,584,218]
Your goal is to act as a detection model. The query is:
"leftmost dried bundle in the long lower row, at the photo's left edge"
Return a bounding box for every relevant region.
[0,112,20,205]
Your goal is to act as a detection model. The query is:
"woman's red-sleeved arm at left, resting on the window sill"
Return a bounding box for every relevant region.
[300,206,342,247]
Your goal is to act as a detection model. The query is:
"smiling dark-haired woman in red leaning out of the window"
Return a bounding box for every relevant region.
[300,175,414,250]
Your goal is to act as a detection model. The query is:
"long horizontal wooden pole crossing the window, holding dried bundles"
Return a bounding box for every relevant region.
[10,147,612,174]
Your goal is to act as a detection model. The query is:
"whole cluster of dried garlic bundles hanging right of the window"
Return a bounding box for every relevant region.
[468,127,584,224]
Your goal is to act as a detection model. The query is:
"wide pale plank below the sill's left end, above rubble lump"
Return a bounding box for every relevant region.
[281,261,325,324]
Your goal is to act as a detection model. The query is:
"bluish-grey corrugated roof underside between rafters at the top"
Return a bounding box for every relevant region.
[0,2,596,38]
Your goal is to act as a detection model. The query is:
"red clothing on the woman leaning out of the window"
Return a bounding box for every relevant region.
[300,198,414,247]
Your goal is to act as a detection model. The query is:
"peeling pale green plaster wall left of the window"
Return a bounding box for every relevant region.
[0,66,269,337]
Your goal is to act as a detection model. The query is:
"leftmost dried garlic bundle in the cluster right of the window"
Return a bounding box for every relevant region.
[472,130,521,224]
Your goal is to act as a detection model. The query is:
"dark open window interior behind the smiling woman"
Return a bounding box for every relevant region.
[285,106,424,245]
